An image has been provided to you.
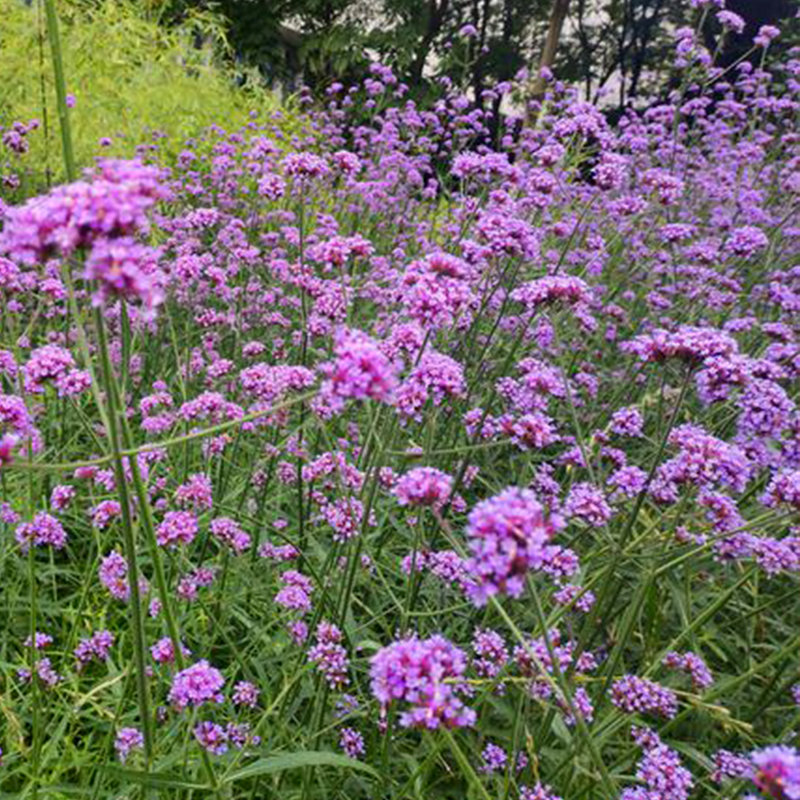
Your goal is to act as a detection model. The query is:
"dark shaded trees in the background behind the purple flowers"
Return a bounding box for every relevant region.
[158,0,797,104]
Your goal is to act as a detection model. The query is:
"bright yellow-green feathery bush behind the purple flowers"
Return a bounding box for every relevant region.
[0,0,286,188]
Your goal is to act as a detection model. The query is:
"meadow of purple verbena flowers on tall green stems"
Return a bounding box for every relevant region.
[0,3,800,800]
